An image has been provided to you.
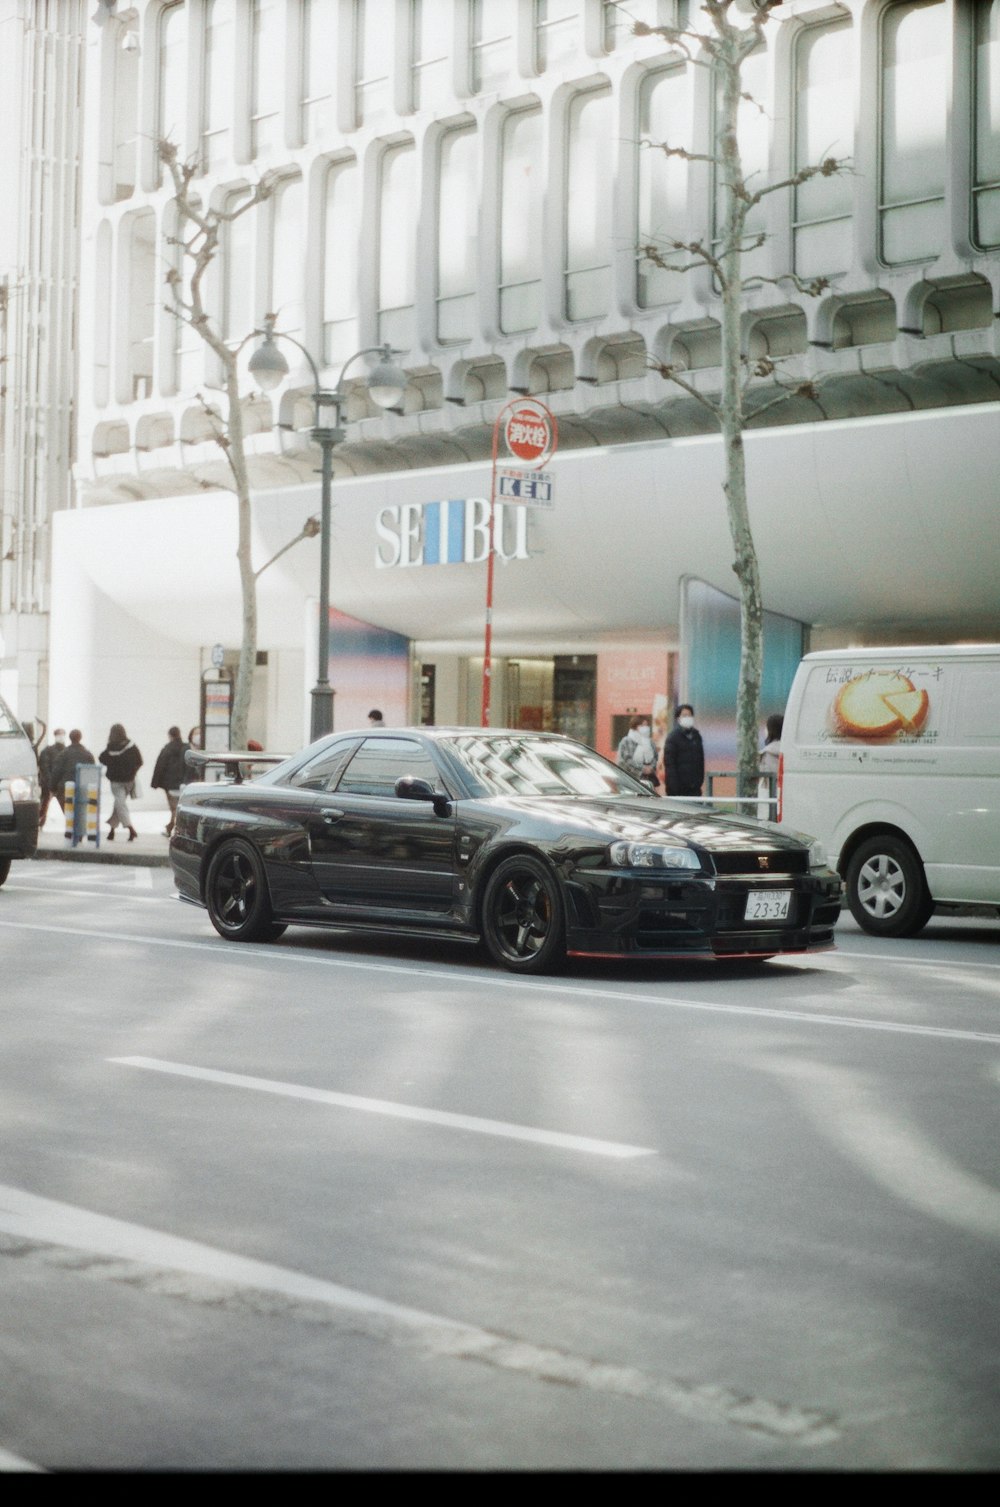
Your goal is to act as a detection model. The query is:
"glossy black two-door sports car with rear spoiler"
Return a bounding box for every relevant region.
[170,728,842,974]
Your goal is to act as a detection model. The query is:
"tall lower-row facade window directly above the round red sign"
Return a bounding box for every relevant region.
[500,109,545,335]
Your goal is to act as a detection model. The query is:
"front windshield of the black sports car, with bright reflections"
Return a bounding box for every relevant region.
[450,734,651,797]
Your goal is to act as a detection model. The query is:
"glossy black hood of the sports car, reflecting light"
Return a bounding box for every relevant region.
[497,796,812,853]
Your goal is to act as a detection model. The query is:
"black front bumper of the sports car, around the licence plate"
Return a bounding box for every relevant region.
[566,870,843,958]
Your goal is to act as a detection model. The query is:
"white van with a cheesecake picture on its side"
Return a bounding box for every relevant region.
[777,643,1000,936]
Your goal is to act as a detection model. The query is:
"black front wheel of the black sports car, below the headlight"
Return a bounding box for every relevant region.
[482,853,566,974]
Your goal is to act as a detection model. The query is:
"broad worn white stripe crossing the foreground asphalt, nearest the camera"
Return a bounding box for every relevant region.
[0,1186,840,1447]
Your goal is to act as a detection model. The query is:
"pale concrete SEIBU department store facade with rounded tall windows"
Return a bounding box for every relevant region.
[35,0,1000,757]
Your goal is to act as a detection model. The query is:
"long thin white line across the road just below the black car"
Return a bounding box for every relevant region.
[0,921,1000,1046]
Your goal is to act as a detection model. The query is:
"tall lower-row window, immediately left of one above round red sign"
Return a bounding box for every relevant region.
[438,125,479,342]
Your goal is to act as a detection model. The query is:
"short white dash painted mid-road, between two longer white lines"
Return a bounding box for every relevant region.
[108,1056,657,1160]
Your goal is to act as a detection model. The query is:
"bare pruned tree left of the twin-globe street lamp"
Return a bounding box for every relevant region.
[157,140,319,749]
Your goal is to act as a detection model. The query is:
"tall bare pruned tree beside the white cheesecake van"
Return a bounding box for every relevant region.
[633,0,845,799]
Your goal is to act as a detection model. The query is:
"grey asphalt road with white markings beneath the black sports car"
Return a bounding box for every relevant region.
[0,862,1000,1471]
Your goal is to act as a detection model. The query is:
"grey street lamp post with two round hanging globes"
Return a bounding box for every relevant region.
[248,315,407,741]
